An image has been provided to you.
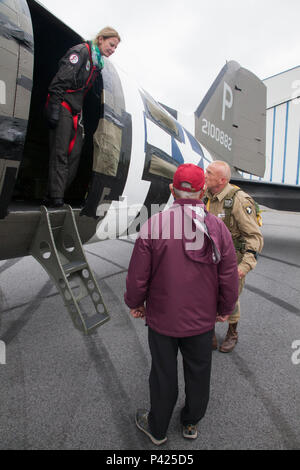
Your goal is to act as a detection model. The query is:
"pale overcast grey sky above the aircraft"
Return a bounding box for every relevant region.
[39,0,300,113]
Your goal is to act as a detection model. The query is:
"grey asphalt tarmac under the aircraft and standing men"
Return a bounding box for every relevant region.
[0,210,300,452]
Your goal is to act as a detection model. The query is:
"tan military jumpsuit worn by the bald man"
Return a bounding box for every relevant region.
[204,183,263,324]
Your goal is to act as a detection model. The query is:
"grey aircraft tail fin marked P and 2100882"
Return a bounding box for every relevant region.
[195,61,267,177]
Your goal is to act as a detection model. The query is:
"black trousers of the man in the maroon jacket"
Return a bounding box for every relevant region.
[148,328,213,439]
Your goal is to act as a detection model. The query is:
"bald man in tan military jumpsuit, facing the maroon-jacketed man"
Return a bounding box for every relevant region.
[204,161,263,353]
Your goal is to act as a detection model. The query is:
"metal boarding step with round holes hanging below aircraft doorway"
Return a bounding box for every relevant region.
[30,205,109,333]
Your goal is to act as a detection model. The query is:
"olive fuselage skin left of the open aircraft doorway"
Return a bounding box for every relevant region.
[0,0,33,218]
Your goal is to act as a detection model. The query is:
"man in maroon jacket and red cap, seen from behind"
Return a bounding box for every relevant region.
[124,164,238,445]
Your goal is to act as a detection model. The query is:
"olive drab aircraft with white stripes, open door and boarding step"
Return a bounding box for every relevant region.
[0,0,290,333]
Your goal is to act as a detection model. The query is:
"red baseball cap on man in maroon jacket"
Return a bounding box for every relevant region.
[173,163,205,193]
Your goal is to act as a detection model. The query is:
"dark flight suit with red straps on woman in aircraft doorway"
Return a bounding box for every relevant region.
[46,43,101,199]
